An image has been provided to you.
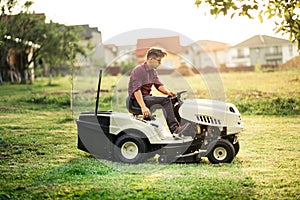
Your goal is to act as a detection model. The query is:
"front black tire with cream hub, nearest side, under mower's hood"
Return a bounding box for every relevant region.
[207,139,235,164]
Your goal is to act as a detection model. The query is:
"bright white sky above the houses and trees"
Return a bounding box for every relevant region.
[31,0,286,45]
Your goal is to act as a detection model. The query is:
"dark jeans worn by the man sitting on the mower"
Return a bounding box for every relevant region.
[143,96,178,133]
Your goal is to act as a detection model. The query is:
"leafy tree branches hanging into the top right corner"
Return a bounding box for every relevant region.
[195,0,300,50]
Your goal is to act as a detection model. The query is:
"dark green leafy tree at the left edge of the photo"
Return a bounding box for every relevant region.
[0,0,85,82]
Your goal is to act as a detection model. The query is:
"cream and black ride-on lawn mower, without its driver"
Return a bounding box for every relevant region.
[76,70,243,164]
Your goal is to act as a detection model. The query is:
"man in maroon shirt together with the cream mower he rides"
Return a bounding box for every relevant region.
[76,49,243,164]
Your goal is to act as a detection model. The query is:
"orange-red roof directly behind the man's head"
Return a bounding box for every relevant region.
[135,36,181,56]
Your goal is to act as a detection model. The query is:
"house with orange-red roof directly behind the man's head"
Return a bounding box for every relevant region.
[135,36,181,69]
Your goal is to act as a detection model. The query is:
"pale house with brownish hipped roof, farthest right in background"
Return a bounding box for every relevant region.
[227,35,297,67]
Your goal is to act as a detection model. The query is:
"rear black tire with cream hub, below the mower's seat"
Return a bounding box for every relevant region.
[114,134,147,164]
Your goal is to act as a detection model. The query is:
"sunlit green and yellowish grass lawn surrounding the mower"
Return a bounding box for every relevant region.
[0,71,300,199]
